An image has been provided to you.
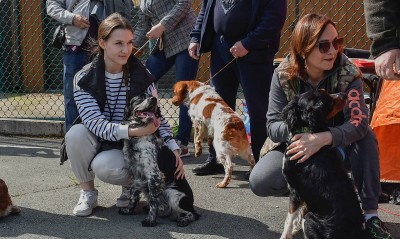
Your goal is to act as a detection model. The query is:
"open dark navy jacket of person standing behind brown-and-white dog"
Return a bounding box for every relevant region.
[190,0,287,61]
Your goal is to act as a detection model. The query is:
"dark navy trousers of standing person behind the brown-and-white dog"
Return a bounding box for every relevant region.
[207,36,273,162]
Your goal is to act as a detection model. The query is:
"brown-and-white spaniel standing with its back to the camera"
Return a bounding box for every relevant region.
[172,81,255,188]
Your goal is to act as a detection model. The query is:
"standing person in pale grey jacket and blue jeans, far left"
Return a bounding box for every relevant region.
[46,0,132,132]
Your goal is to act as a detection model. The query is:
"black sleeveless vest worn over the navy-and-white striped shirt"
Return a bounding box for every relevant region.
[78,55,154,112]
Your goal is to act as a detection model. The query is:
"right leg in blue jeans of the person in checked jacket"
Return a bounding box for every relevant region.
[175,50,199,157]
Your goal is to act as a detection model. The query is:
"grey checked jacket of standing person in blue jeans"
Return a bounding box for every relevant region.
[134,0,196,58]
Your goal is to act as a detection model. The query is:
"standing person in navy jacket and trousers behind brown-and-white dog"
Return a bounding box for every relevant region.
[188,0,287,175]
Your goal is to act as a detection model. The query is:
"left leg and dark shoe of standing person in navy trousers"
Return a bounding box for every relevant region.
[193,37,239,175]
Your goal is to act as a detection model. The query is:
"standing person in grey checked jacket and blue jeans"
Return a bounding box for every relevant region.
[134,0,198,157]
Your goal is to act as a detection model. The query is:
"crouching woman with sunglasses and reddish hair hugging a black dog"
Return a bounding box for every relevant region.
[249,14,391,238]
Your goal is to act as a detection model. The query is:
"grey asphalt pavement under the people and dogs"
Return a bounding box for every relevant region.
[0,136,400,239]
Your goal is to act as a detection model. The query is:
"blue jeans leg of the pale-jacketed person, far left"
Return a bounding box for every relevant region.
[63,50,89,132]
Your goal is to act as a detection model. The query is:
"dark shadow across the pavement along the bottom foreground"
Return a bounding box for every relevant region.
[0,206,279,239]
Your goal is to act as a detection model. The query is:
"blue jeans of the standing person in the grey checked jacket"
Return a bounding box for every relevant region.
[146,50,199,145]
